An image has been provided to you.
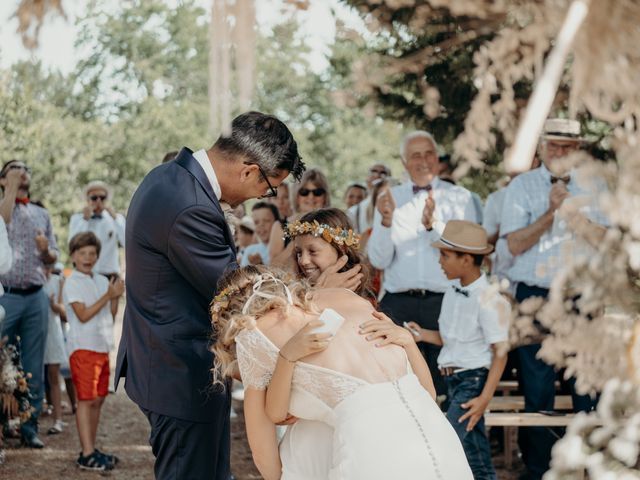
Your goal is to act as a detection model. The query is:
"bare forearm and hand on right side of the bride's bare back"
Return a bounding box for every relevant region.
[360,312,436,400]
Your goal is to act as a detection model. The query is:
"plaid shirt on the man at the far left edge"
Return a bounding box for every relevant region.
[0,203,58,288]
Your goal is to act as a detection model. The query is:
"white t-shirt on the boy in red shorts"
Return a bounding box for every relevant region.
[62,270,113,355]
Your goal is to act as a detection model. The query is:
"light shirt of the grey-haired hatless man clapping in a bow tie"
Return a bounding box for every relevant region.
[367,177,476,293]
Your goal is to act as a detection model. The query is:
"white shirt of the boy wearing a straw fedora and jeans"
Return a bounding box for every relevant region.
[438,275,511,368]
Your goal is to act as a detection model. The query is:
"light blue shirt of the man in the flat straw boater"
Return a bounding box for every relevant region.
[500,165,608,288]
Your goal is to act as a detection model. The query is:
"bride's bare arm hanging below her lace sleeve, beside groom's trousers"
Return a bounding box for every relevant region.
[244,387,282,480]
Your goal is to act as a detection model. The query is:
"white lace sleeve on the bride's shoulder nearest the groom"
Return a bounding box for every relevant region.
[236,330,278,390]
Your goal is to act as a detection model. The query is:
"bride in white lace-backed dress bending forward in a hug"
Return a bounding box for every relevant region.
[212,266,473,480]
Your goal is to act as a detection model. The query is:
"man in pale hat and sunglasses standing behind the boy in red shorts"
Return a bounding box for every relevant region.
[69,181,125,280]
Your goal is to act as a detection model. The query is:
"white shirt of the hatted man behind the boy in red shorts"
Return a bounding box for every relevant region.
[69,210,126,275]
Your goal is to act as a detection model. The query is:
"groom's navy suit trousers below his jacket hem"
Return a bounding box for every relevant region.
[141,408,231,480]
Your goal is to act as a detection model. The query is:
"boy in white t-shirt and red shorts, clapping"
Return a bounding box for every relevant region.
[63,232,124,471]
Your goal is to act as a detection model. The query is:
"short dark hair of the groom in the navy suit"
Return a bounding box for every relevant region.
[213,112,305,180]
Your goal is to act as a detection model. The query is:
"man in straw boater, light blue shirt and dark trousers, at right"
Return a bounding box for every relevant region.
[500,118,607,479]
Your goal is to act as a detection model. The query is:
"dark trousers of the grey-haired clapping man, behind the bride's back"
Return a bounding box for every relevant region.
[380,292,447,395]
